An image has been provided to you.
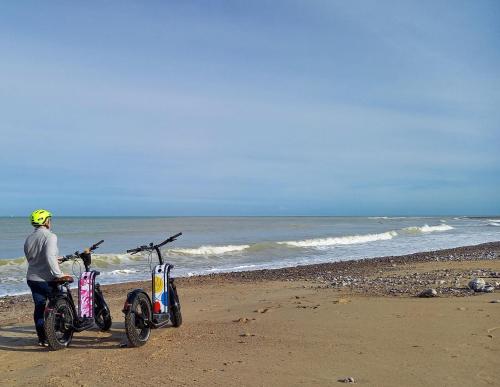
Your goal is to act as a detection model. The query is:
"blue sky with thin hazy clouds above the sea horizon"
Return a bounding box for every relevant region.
[0,0,500,216]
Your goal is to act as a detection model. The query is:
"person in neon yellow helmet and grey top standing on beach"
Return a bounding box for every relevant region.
[24,209,65,346]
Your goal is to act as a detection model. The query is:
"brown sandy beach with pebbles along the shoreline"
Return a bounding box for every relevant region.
[0,242,500,386]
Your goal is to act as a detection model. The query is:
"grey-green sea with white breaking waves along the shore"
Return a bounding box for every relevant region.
[0,216,500,296]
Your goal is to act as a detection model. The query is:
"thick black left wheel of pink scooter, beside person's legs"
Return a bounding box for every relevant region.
[44,298,75,351]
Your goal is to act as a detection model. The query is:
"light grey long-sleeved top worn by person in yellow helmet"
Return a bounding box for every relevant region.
[24,227,63,281]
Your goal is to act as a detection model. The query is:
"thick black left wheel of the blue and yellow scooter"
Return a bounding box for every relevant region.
[125,293,152,347]
